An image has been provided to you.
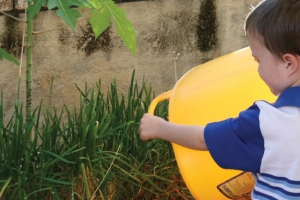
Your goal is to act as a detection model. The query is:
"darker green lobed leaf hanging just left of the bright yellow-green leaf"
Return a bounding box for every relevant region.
[48,0,83,30]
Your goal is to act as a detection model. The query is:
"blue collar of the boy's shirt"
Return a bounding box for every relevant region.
[273,86,300,108]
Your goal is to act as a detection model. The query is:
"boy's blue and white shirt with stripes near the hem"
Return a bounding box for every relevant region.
[204,87,300,200]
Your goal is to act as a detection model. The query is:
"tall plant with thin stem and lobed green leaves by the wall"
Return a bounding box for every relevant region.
[0,0,136,122]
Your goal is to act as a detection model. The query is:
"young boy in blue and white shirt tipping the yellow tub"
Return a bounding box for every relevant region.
[139,0,300,200]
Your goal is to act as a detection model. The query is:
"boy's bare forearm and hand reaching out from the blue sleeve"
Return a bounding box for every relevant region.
[139,114,207,150]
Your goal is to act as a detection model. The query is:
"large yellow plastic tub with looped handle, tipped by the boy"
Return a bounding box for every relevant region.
[149,47,276,200]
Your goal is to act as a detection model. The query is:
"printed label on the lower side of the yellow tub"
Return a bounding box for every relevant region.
[217,172,255,200]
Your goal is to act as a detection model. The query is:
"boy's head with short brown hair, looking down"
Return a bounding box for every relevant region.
[245,0,300,95]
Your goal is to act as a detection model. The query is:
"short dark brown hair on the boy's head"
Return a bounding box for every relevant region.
[245,0,300,57]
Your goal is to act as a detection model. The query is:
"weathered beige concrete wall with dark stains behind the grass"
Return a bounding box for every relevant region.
[0,0,258,119]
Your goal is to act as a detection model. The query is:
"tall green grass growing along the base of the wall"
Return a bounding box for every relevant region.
[0,72,192,200]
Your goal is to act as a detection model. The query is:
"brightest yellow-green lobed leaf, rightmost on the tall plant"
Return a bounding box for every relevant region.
[89,0,136,55]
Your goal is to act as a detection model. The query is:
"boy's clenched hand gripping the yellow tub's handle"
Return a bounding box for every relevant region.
[139,113,166,140]
